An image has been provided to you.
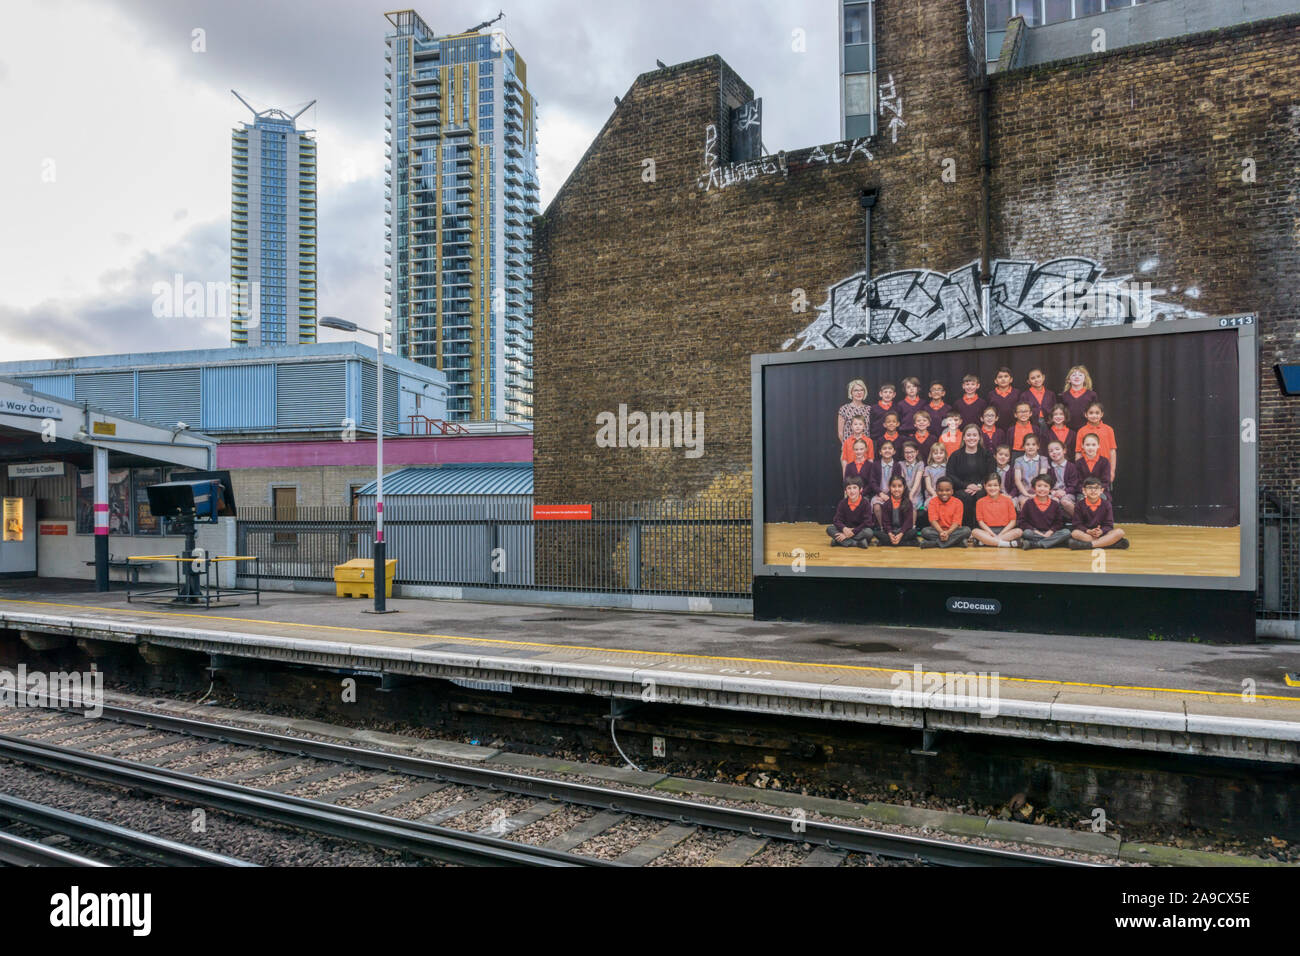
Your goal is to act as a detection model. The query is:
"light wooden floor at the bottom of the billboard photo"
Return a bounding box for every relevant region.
[763,523,1242,578]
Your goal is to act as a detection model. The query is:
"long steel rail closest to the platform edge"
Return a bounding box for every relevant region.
[76,705,1100,868]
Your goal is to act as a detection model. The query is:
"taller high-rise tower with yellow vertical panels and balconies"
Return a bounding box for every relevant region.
[385,10,538,421]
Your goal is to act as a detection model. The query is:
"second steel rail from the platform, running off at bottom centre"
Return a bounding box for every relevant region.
[0,735,605,866]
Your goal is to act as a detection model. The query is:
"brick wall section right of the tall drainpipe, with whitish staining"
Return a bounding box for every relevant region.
[991,17,1300,486]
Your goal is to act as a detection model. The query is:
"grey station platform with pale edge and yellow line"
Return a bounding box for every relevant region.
[0,580,1300,763]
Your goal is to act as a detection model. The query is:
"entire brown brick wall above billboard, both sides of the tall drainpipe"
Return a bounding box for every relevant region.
[534,0,1300,502]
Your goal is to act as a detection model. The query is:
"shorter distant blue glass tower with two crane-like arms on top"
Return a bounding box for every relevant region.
[230,91,316,346]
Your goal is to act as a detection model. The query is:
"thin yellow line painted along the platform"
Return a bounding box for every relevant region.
[0,598,1300,704]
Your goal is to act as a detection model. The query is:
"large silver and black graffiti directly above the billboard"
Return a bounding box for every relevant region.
[781,258,1204,351]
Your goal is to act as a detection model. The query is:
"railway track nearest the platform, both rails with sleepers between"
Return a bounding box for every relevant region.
[0,706,1096,866]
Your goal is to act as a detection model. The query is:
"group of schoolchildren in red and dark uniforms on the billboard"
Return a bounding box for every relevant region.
[827,365,1128,550]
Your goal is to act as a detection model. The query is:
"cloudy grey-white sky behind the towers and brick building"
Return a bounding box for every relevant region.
[0,0,839,360]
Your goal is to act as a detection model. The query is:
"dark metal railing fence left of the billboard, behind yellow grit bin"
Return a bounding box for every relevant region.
[237,496,753,598]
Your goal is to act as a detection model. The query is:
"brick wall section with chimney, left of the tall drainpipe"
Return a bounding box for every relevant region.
[534,0,979,502]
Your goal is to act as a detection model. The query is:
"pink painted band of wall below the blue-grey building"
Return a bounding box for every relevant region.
[217,434,533,471]
